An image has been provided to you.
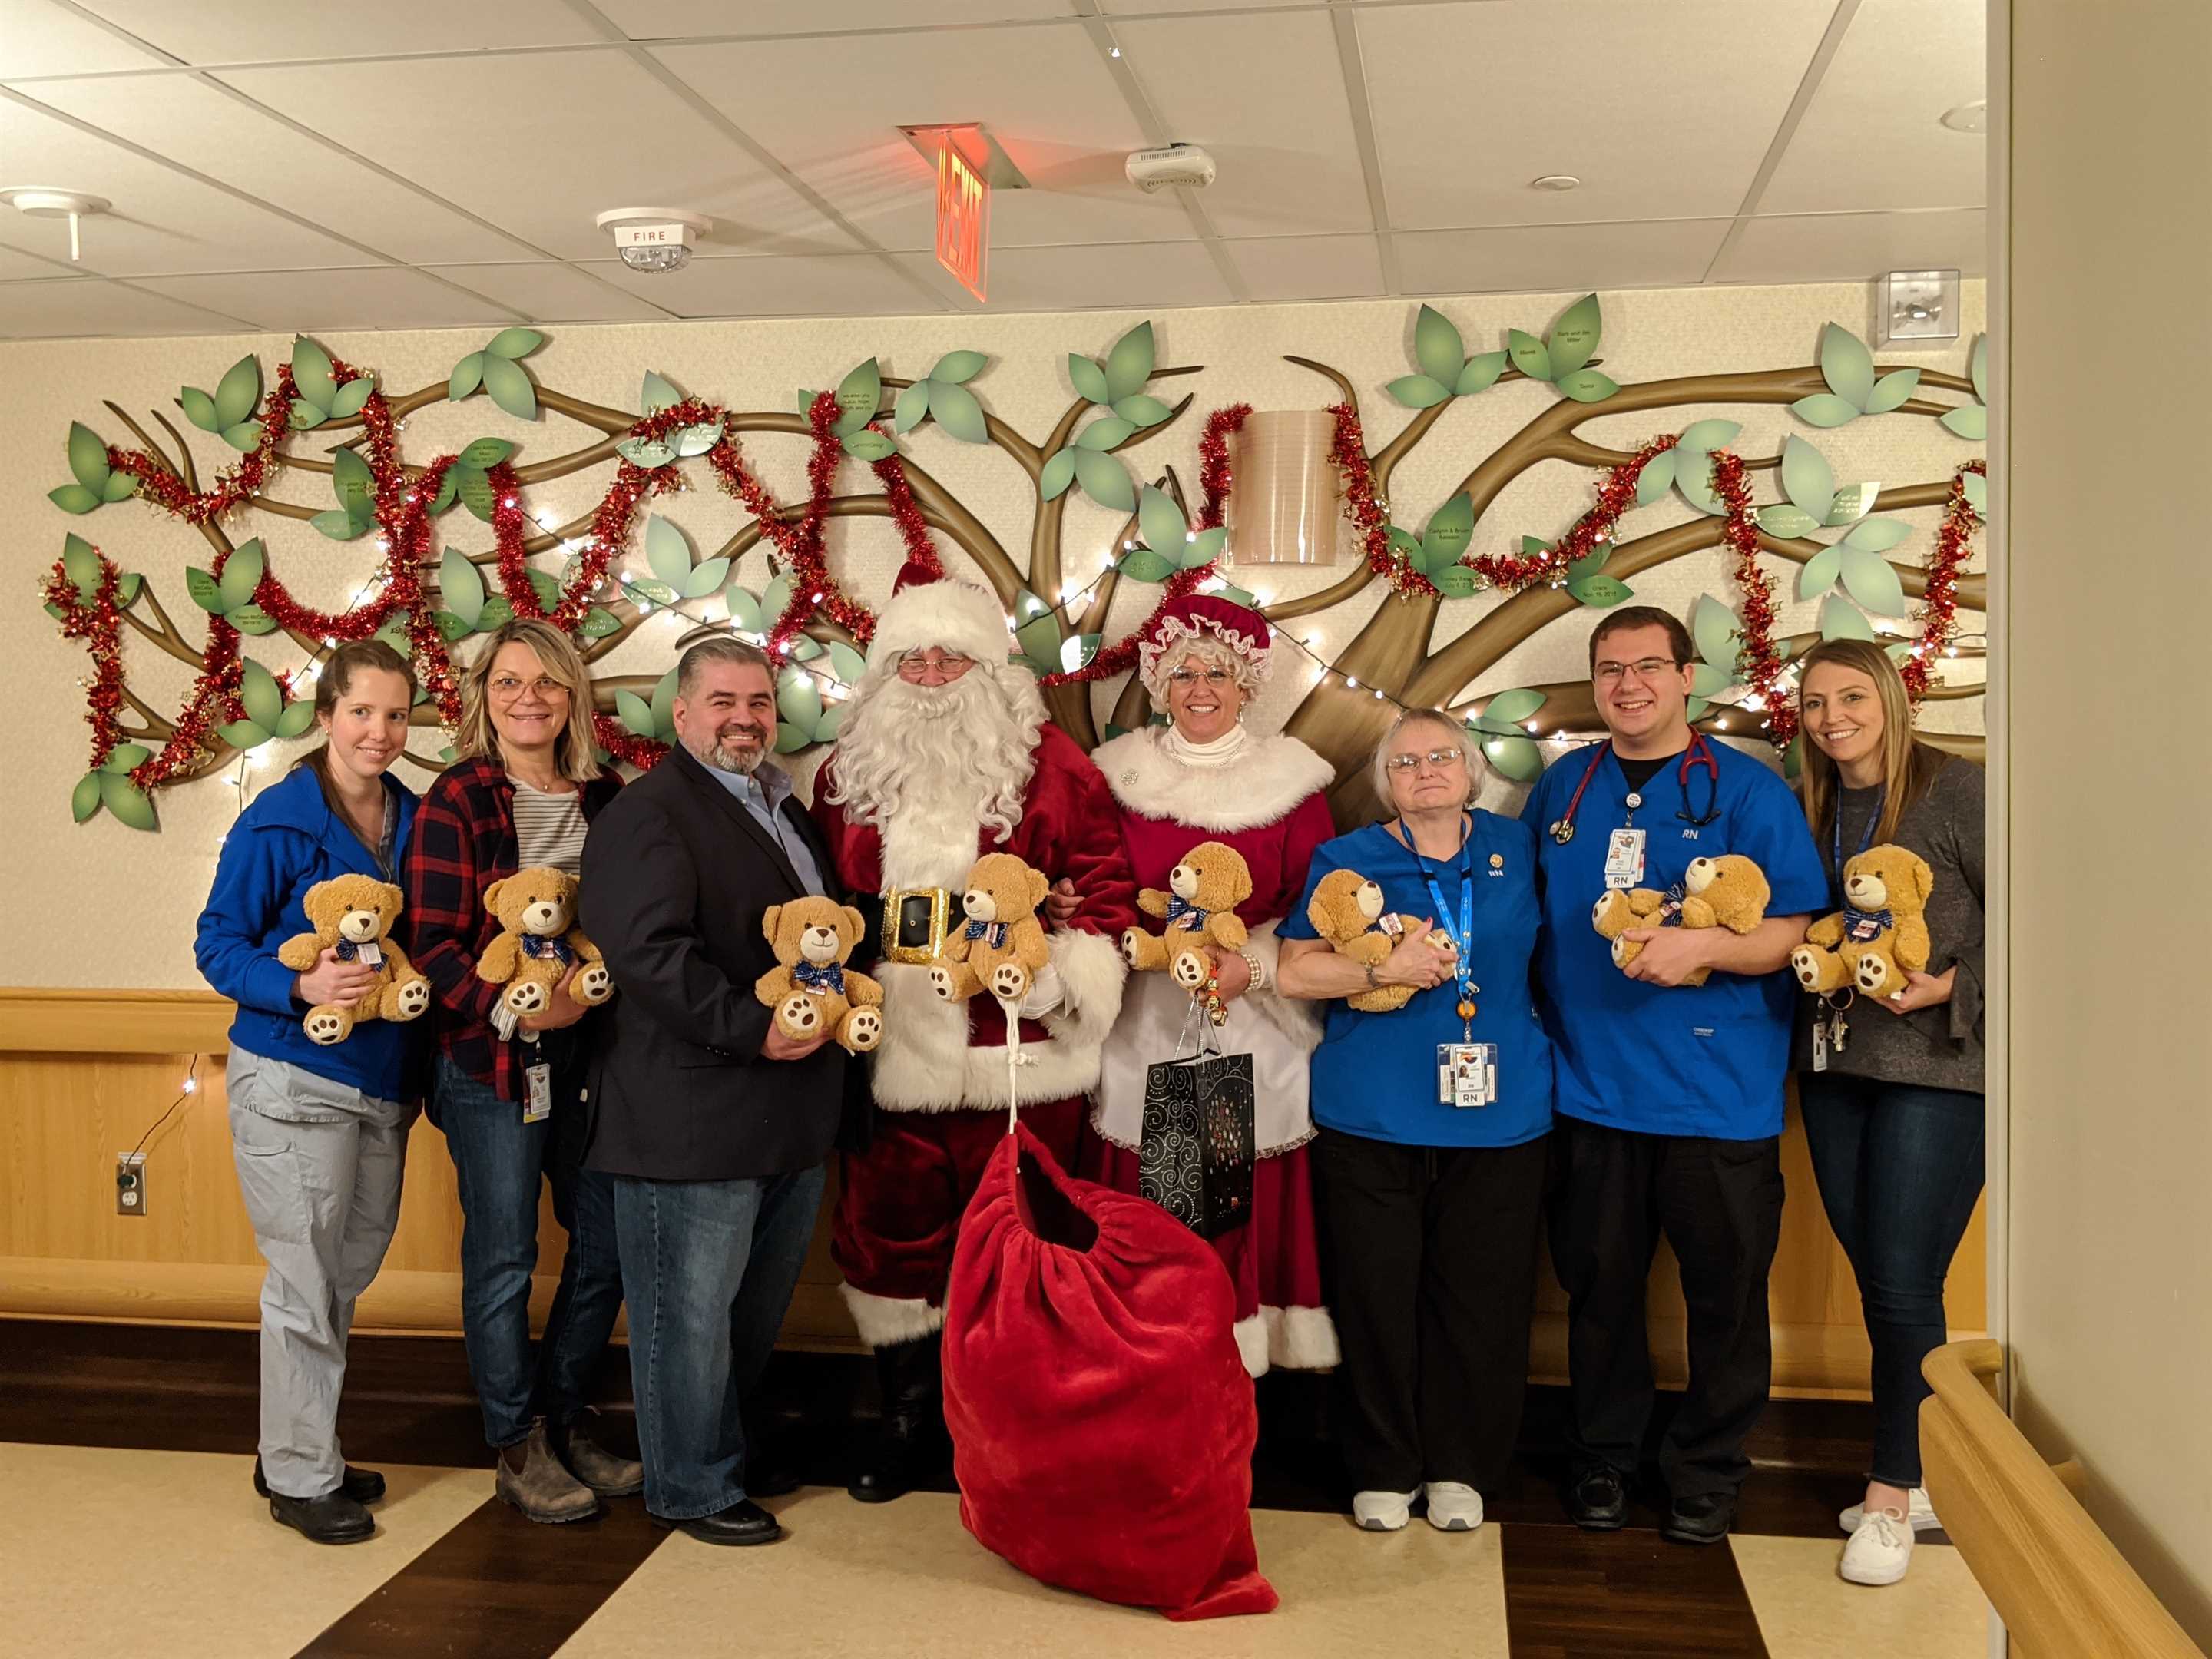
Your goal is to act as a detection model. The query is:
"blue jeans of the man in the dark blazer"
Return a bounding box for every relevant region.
[613,1164,825,1520]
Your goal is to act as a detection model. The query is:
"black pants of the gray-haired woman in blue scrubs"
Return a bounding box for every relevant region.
[1314,1128,1551,1491]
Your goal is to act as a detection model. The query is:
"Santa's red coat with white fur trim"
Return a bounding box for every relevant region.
[814,726,1139,1113]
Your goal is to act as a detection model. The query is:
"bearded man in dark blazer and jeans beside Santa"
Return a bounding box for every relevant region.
[581,639,845,1544]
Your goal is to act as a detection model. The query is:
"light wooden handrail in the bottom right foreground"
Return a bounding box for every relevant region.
[1920,1340,2203,1659]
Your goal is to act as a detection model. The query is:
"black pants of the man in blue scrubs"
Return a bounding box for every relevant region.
[1551,1117,1783,1500]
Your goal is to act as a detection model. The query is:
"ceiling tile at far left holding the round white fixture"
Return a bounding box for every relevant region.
[0,100,378,276]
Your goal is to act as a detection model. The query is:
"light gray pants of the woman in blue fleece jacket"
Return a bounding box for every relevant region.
[228,1048,414,1498]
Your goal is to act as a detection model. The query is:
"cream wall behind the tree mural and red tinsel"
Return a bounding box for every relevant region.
[0,283,1982,988]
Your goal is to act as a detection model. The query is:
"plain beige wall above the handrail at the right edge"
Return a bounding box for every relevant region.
[2000,0,2212,1646]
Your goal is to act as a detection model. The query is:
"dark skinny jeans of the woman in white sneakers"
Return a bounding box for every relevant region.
[1798,1071,1982,1486]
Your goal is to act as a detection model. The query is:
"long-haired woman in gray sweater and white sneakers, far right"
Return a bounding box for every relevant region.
[1794,639,1984,1584]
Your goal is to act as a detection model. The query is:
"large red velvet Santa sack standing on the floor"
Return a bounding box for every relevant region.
[945,1128,1277,1619]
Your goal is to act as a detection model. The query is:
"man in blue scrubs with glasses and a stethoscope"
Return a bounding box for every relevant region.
[1522,606,1827,1544]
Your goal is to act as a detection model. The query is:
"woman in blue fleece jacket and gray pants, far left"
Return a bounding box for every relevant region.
[194,639,429,1544]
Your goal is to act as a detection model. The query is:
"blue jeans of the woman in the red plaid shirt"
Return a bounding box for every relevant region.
[432,1052,621,1447]
